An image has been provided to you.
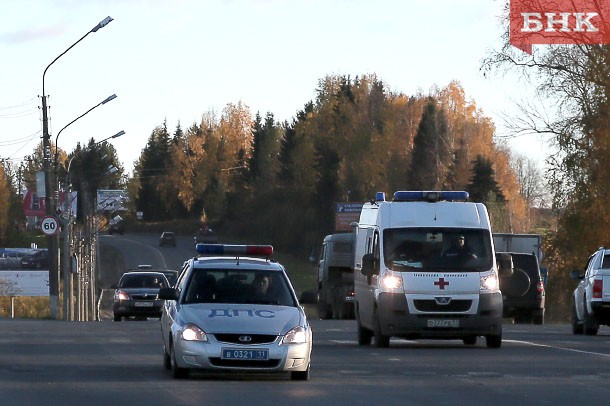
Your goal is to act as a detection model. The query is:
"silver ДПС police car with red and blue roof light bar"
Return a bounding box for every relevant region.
[159,244,312,380]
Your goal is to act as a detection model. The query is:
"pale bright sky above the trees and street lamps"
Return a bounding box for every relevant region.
[0,0,547,171]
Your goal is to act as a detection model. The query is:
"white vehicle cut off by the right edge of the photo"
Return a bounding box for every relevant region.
[571,247,610,335]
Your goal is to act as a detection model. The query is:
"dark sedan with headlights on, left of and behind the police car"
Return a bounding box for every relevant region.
[113,271,170,321]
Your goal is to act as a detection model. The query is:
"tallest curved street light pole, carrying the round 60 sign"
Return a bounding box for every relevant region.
[42,16,112,320]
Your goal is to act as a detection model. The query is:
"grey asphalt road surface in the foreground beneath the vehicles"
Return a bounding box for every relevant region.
[0,319,610,406]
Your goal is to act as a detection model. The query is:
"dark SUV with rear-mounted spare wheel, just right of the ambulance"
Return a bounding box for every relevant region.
[496,252,546,324]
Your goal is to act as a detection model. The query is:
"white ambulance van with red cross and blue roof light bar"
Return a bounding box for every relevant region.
[353,191,504,348]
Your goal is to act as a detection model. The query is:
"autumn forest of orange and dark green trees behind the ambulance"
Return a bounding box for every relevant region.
[128,75,539,251]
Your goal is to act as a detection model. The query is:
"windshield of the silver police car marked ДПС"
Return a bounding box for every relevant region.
[183,269,297,307]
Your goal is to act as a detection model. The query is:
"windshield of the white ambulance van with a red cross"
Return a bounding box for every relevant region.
[383,228,492,271]
